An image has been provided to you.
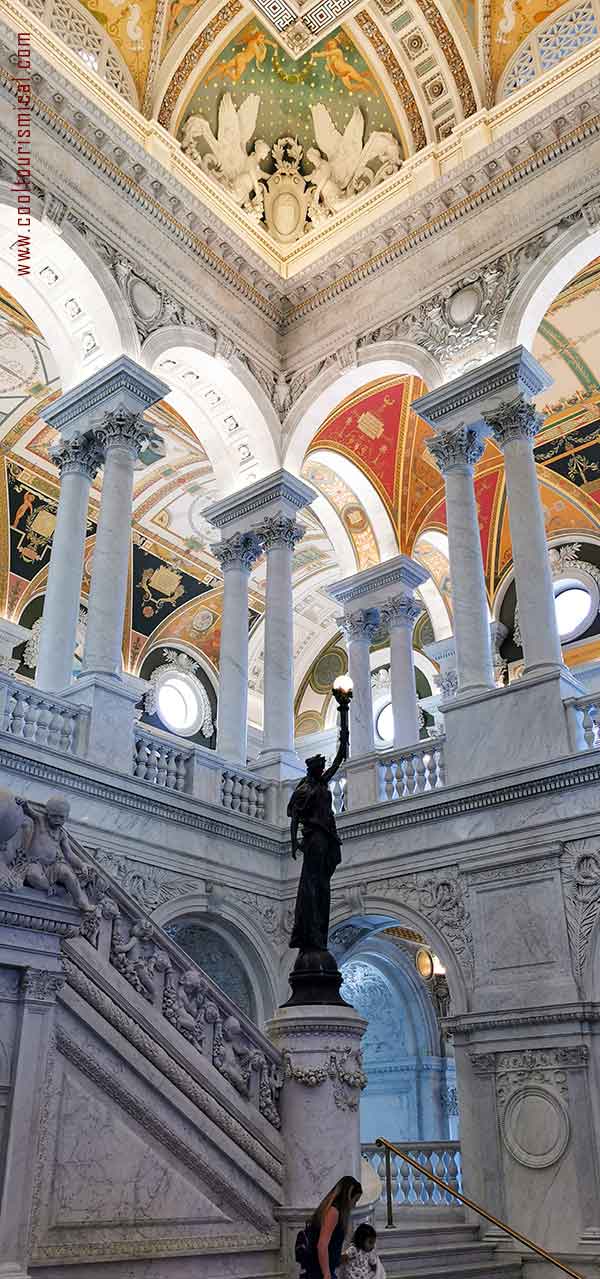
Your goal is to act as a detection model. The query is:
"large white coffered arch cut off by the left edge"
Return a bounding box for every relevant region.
[0,183,139,391]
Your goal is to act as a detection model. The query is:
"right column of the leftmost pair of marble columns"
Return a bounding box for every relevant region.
[83,408,152,675]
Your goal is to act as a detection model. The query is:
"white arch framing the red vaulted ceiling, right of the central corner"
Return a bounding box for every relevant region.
[283,341,444,475]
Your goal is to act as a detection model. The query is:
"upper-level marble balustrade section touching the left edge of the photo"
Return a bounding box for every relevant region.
[1,680,90,755]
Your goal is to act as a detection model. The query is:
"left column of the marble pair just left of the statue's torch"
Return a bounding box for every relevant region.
[211,533,262,766]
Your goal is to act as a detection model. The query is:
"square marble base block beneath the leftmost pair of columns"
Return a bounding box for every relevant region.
[63,671,142,775]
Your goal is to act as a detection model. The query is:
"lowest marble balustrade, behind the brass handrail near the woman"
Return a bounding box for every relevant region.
[361,1138,462,1207]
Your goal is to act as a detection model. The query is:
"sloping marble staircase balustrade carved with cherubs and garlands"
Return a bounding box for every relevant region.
[0,799,283,1128]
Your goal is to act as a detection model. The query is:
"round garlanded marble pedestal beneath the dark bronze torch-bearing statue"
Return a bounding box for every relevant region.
[266,1004,367,1276]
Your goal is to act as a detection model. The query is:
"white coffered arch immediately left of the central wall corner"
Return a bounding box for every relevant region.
[142,325,280,495]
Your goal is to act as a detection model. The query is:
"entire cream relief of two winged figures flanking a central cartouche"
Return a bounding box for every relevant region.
[182,93,402,243]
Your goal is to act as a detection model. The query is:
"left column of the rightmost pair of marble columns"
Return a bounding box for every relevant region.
[427,427,494,693]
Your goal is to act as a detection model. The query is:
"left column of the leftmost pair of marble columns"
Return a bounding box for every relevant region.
[36,435,102,692]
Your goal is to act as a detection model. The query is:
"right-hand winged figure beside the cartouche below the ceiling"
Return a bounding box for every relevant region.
[307,102,402,211]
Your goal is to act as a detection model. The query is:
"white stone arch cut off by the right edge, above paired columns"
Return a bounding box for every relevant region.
[496,217,600,354]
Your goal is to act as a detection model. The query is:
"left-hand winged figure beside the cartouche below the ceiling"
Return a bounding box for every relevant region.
[182,93,269,205]
